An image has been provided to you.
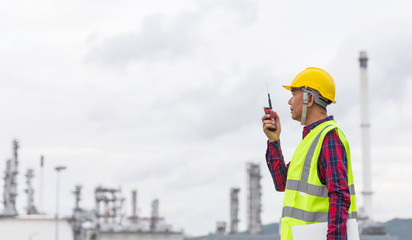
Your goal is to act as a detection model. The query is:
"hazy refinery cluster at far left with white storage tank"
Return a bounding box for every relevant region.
[0,140,184,240]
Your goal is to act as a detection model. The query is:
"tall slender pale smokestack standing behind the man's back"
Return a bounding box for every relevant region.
[359,51,372,220]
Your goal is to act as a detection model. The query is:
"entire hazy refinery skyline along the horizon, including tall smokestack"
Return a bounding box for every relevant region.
[0,52,406,240]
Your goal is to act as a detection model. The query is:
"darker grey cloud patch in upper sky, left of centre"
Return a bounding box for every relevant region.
[89,14,198,65]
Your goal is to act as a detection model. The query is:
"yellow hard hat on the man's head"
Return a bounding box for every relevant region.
[283,67,336,103]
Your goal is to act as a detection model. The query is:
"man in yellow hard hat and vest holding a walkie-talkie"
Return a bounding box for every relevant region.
[262,67,356,240]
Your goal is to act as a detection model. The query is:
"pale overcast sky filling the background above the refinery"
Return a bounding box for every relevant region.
[0,0,412,235]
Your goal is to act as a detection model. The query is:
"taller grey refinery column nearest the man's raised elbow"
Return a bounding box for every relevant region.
[247,163,262,234]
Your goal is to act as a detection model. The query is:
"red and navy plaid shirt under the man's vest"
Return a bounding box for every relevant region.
[266,116,350,240]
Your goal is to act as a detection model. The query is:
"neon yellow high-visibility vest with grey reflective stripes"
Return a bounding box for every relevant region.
[281,120,357,240]
